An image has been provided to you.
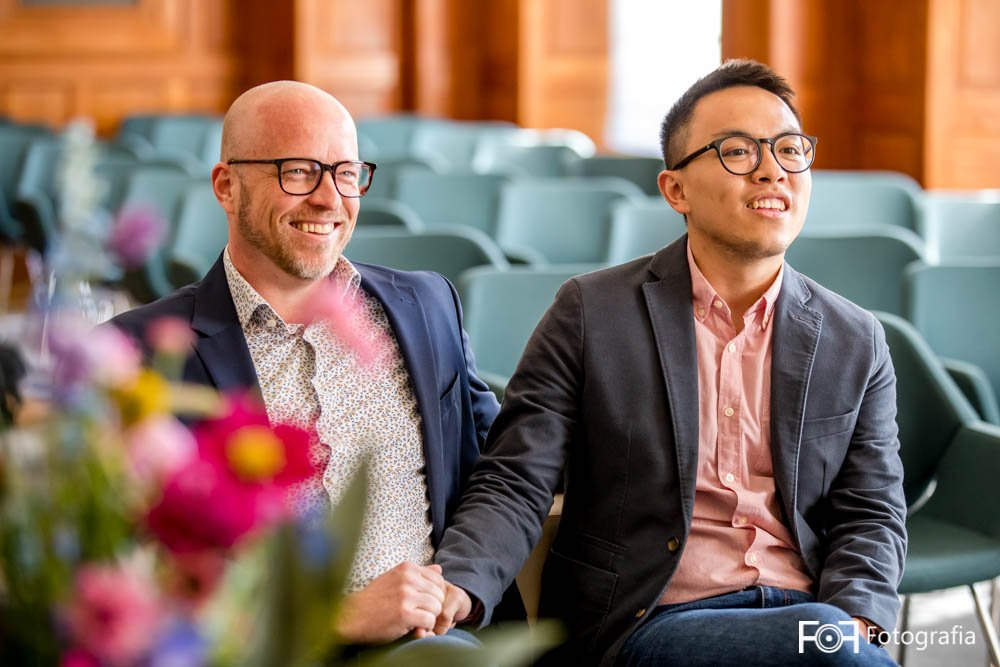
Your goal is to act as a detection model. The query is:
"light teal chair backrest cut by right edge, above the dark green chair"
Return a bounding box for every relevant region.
[905,260,1000,404]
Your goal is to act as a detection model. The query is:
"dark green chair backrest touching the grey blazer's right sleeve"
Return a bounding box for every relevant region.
[876,313,977,506]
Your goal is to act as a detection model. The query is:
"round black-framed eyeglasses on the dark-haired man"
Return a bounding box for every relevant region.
[671,132,819,176]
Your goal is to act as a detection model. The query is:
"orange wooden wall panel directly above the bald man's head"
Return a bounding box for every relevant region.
[292,0,406,117]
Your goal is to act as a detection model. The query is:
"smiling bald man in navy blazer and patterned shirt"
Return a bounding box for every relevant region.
[112,81,512,645]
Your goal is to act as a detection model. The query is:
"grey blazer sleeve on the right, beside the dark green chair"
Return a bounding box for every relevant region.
[817,317,906,630]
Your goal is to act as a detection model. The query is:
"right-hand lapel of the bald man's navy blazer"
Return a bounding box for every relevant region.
[354,263,447,544]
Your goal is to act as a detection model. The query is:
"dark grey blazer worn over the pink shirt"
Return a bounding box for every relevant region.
[436,236,906,664]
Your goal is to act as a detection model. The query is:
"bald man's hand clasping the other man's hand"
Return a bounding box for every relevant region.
[333,561,450,644]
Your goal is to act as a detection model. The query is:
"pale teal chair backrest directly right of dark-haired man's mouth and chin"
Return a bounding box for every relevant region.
[805,169,922,232]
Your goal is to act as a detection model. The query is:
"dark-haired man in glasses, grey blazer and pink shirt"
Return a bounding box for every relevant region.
[435,61,906,667]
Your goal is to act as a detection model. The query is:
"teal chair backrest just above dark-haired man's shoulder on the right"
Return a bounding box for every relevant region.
[785,226,923,315]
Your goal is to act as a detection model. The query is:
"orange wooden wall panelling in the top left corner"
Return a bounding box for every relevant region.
[0,0,238,134]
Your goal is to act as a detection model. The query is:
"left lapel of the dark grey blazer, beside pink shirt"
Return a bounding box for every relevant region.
[642,234,698,528]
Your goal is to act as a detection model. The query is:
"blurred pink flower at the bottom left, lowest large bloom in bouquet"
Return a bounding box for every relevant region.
[66,565,161,665]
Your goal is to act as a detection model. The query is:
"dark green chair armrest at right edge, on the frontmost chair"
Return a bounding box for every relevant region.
[920,422,1000,538]
